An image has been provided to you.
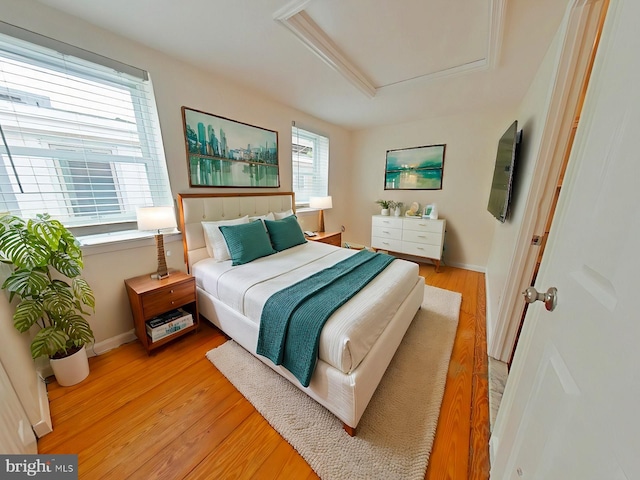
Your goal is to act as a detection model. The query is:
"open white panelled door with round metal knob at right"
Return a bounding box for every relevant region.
[491,0,640,480]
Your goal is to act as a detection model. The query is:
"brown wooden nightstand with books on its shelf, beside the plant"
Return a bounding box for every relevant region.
[124,271,199,353]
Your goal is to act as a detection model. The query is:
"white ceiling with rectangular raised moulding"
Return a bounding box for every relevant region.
[33,0,568,129]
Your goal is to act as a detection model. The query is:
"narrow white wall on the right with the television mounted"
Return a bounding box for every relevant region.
[486,28,560,351]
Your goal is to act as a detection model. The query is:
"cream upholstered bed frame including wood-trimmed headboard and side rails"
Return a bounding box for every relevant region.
[178,192,424,436]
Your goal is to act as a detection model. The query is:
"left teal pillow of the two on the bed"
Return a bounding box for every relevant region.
[219,220,276,265]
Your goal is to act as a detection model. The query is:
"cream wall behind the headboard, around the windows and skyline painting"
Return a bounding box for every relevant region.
[0,0,350,372]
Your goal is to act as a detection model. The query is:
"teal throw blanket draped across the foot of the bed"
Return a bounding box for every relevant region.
[256,250,394,387]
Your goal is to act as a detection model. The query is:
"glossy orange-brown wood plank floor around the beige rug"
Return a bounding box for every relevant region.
[38,265,489,480]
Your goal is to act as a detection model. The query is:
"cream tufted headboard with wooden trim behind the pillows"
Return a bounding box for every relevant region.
[178,192,295,272]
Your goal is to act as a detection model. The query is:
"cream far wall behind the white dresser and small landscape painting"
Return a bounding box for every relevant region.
[344,107,516,271]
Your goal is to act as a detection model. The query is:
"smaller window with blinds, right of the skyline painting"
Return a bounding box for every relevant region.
[291,123,329,206]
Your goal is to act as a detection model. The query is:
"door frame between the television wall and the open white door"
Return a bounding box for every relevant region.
[487,0,609,362]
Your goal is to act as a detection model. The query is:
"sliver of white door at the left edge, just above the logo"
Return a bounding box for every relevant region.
[0,360,38,454]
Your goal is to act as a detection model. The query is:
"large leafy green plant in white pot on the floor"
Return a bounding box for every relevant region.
[0,214,95,386]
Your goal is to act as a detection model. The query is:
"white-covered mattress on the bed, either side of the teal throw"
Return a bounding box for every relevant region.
[193,242,418,373]
